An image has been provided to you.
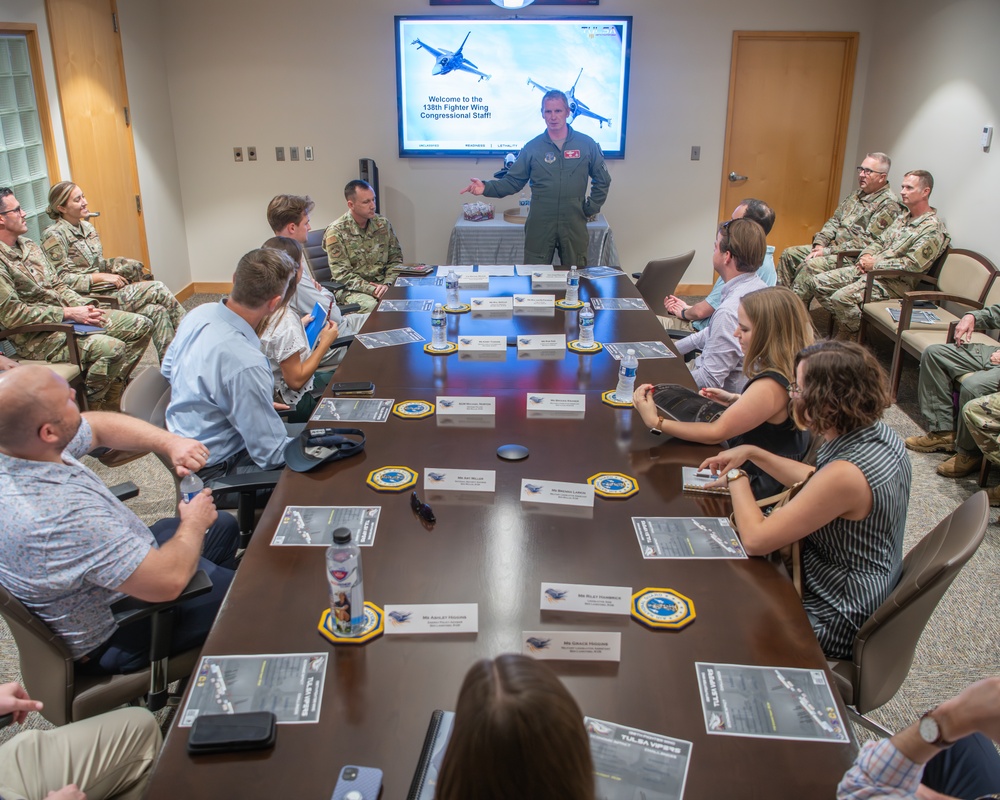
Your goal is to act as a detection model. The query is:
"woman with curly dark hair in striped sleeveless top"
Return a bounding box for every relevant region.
[702,341,910,658]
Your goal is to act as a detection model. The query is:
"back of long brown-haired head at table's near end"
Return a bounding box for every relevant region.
[434,654,594,800]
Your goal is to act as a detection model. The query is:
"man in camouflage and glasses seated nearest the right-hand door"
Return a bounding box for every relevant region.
[778,153,903,306]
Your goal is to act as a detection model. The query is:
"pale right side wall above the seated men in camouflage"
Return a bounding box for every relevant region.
[859,0,1000,256]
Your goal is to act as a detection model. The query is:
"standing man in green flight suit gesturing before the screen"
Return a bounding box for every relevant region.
[460,90,611,267]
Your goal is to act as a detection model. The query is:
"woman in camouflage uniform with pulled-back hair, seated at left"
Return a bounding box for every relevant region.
[41,181,184,360]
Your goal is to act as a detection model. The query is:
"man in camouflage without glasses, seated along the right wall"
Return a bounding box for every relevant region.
[812,169,951,336]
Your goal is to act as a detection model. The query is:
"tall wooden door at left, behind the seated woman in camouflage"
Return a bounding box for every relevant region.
[45,0,148,267]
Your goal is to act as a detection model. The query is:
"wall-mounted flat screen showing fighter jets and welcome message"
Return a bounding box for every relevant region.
[395,16,632,158]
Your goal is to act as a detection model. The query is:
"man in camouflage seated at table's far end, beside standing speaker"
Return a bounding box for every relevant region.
[323,181,403,314]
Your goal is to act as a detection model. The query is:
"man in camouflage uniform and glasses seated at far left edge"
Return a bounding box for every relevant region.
[0,189,152,410]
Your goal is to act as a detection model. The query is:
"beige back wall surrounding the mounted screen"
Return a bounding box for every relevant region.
[115,0,868,282]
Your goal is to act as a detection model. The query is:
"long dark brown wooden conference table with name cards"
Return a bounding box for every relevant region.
[149,277,855,800]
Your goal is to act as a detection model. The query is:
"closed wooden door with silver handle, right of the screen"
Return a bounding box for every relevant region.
[719,31,858,257]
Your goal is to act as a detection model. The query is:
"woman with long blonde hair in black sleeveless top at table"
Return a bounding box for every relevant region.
[632,286,813,498]
